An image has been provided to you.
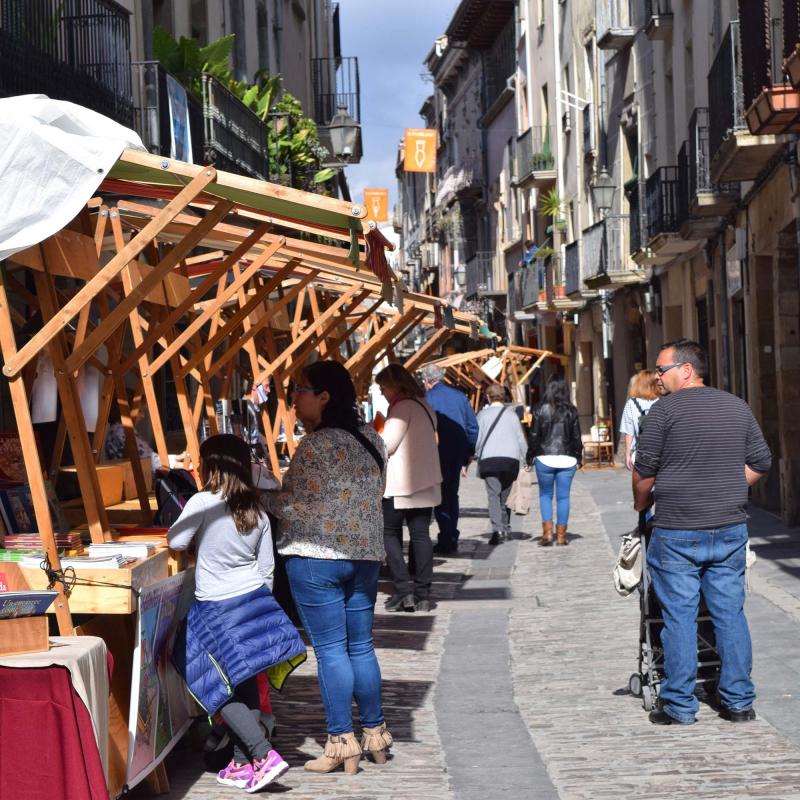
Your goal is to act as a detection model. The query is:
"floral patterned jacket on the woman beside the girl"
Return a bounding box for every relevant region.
[266,426,386,561]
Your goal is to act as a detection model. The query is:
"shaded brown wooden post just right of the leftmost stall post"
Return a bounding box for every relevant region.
[33,268,108,544]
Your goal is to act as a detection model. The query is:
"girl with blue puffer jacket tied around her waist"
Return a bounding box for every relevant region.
[167,434,305,793]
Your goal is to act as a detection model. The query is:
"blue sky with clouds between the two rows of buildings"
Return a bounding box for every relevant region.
[339,0,459,214]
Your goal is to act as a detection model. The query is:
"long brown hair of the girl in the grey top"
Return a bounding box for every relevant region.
[200,433,264,533]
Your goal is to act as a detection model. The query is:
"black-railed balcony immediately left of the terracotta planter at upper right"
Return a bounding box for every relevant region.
[708,21,786,183]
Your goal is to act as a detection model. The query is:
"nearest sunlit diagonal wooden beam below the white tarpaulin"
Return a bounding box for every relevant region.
[3,167,217,378]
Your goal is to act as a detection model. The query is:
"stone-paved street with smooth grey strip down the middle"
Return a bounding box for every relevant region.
[142,470,800,800]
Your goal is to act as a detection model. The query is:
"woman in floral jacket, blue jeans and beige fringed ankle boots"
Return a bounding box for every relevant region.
[267,361,392,774]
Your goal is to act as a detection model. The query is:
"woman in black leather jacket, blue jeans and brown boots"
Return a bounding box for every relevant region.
[527,375,583,547]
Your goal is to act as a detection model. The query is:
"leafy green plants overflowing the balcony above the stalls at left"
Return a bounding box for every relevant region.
[153,26,336,191]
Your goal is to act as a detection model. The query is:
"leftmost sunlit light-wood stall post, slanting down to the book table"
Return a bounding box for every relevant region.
[0,266,74,636]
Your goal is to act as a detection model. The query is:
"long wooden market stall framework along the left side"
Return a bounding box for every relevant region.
[0,145,475,792]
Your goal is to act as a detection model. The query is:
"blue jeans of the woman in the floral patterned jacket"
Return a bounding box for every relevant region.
[286,556,383,736]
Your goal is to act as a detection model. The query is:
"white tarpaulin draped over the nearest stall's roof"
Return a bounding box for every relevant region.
[0,94,144,260]
